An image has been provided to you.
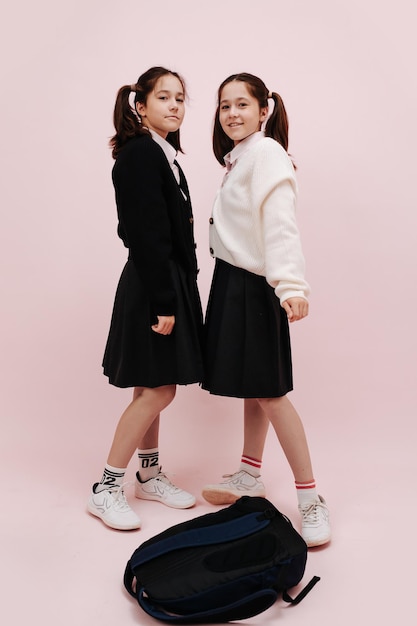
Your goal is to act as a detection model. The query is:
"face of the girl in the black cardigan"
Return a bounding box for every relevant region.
[136,74,185,139]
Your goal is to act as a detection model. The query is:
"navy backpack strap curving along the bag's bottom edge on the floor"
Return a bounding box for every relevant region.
[137,589,278,624]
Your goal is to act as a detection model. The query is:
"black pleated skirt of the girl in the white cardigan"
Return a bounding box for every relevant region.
[202,259,293,398]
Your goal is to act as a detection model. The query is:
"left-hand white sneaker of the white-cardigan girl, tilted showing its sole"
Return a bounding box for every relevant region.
[202,470,266,504]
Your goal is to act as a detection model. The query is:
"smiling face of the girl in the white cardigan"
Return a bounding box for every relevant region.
[219,80,268,145]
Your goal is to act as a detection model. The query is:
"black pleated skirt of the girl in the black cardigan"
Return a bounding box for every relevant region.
[103,260,203,388]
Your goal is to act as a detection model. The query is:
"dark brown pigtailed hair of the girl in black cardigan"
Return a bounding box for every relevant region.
[109,67,186,159]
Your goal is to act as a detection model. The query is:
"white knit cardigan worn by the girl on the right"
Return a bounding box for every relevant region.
[210,132,310,303]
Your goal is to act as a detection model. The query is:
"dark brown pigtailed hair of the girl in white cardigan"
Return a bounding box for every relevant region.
[213,72,288,166]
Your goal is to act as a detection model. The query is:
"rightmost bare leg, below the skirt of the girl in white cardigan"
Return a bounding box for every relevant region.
[258,396,314,483]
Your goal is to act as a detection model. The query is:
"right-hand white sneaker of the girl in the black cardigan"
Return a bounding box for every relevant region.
[135,468,195,509]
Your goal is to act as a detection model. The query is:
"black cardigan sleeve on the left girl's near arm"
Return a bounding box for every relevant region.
[113,137,175,315]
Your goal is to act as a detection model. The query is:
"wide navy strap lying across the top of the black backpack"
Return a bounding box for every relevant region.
[129,511,271,570]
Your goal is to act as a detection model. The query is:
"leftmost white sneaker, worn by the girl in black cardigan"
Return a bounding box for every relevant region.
[87,483,141,530]
